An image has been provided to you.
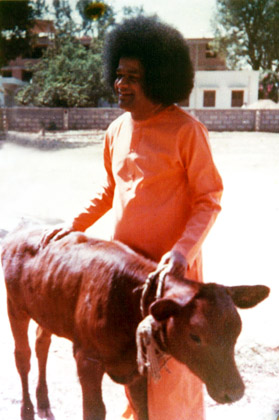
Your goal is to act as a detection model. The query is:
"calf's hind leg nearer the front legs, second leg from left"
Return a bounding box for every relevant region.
[36,326,54,420]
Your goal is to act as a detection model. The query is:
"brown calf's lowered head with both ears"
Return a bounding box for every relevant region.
[150,280,269,404]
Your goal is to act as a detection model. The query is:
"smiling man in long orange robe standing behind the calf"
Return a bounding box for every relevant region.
[45,17,223,420]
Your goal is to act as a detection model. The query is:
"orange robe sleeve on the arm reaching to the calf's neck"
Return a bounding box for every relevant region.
[173,120,223,266]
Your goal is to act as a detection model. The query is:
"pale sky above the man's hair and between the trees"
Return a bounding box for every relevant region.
[47,0,216,38]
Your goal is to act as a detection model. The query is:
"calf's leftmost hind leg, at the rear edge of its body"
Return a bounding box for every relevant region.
[7,300,34,420]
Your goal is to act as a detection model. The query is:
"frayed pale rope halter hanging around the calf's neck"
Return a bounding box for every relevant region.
[136,268,169,382]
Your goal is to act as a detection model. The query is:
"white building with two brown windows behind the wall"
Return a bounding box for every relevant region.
[188,70,259,109]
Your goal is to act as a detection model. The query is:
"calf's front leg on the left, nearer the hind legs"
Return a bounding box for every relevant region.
[74,349,106,420]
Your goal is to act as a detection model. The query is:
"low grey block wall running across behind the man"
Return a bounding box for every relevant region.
[0,107,279,132]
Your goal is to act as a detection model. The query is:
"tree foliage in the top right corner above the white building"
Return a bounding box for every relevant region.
[214,0,279,72]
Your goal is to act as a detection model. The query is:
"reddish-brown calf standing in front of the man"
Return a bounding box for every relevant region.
[2,223,269,420]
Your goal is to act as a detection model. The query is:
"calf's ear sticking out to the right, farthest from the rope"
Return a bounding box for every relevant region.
[226,285,270,309]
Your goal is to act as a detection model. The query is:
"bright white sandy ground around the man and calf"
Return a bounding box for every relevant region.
[0,132,279,420]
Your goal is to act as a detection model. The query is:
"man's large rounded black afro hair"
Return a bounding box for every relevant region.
[104,16,194,105]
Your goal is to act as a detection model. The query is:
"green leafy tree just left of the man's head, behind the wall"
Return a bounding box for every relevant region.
[12,0,149,107]
